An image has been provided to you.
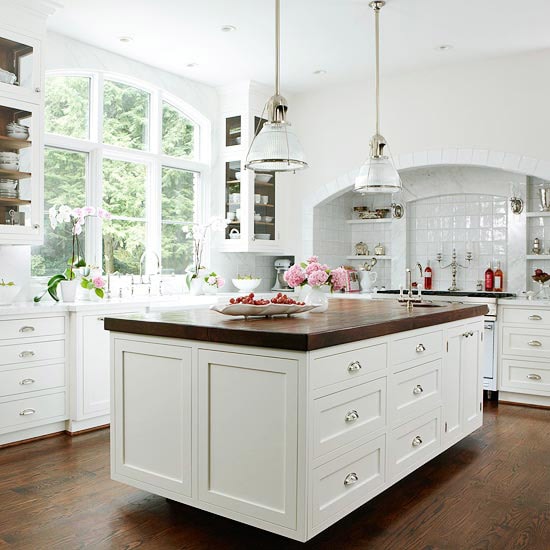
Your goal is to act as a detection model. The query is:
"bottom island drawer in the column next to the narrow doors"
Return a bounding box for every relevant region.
[389,408,441,478]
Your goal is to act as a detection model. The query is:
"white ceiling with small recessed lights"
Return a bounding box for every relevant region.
[49,0,550,91]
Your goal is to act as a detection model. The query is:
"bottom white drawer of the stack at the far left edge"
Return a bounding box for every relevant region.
[0,392,67,431]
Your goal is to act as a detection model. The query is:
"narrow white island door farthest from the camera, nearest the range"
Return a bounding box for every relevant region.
[462,323,483,434]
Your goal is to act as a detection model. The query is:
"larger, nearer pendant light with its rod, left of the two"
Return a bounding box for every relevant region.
[245,0,307,172]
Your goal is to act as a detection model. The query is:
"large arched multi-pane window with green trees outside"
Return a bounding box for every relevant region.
[32,71,210,276]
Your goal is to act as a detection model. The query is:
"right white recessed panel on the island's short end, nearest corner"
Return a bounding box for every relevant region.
[198,350,298,529]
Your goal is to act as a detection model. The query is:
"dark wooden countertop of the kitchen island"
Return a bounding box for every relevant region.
[105,298,487,351]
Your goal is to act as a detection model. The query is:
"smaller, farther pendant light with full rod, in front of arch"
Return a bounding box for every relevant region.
[355,0,402,193]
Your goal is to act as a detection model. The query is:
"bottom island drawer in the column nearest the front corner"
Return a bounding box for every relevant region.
[311,435,386,527]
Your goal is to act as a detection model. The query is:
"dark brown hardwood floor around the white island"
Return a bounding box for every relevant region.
[0,403,550,550]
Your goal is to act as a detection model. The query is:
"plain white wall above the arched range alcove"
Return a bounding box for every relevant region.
[289,50,550,255]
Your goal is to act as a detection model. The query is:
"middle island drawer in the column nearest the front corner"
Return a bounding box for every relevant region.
[313,377,386,457]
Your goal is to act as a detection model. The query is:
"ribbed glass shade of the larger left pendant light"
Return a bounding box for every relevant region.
[246,122,307,172]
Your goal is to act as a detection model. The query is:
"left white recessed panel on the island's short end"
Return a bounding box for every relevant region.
[111,339,192,497]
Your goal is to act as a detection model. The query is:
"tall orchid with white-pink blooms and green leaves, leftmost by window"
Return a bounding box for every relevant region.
[34,204,111,302]
